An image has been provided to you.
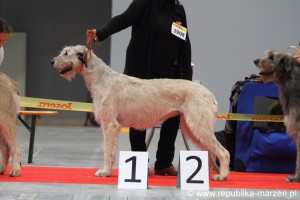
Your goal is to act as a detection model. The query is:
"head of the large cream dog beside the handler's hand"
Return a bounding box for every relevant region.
[51,45,88,81]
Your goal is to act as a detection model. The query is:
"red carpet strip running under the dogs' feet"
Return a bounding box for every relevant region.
[0,166,300,190]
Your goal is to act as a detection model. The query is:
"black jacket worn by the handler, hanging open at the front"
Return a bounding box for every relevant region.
[96,0,193,80]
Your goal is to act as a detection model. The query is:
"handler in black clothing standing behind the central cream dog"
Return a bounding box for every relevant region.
[87,0,193,176]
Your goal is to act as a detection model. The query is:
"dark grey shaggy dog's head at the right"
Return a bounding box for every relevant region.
[254,50,295,82]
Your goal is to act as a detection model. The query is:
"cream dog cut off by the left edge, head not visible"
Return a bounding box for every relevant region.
[0,72,21,176]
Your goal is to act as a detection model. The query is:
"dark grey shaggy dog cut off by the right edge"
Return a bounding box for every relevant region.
[254,50,300,182]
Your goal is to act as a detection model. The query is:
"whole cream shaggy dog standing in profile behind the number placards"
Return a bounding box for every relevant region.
[52,45,229,180]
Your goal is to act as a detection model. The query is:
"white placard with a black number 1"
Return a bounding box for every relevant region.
[118,151,148,189]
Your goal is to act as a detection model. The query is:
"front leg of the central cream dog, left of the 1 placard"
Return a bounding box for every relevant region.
[95,120,121,176]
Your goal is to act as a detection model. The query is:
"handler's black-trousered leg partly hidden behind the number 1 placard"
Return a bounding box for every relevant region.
[129,128,147,151]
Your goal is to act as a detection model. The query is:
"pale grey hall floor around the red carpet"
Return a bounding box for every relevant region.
[0,125,300,200]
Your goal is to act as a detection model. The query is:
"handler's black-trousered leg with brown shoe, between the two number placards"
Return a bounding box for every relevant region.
[155,116,179,175]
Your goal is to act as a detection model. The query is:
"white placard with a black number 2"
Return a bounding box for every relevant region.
[179,151,209,190]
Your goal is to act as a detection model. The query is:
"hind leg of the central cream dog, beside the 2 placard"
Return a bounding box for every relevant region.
[180,114,230,181]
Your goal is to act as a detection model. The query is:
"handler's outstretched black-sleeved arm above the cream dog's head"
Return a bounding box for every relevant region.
[96,0,145,41]
